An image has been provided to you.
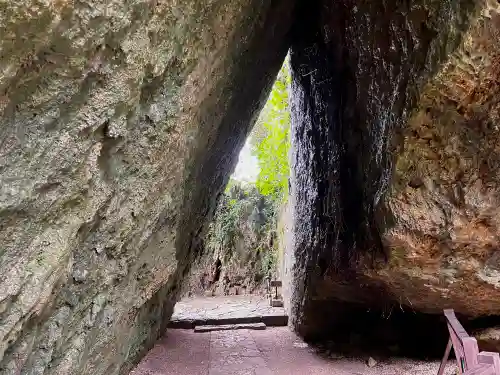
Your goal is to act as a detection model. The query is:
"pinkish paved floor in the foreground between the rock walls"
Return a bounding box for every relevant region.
[130,327,455,375]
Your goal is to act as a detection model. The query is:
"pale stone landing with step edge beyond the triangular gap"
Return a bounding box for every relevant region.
[169,296,288,329]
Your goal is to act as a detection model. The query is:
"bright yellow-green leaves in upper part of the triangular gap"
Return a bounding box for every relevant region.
[251,62,290,201]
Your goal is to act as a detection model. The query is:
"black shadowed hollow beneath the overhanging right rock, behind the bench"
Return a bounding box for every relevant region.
[305,301,500,361]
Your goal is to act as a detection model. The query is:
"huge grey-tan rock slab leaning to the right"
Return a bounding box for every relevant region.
[0,0,293,375]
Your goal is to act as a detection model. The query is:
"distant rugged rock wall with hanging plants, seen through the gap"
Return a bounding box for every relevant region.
[183,182,278,296]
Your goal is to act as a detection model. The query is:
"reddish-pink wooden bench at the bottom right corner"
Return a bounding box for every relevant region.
[438,310,500,375]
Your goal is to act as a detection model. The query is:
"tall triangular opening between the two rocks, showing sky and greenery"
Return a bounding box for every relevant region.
[179,57,290,302]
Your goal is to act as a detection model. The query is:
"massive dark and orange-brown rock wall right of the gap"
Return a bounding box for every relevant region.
[291,0,500,350]
